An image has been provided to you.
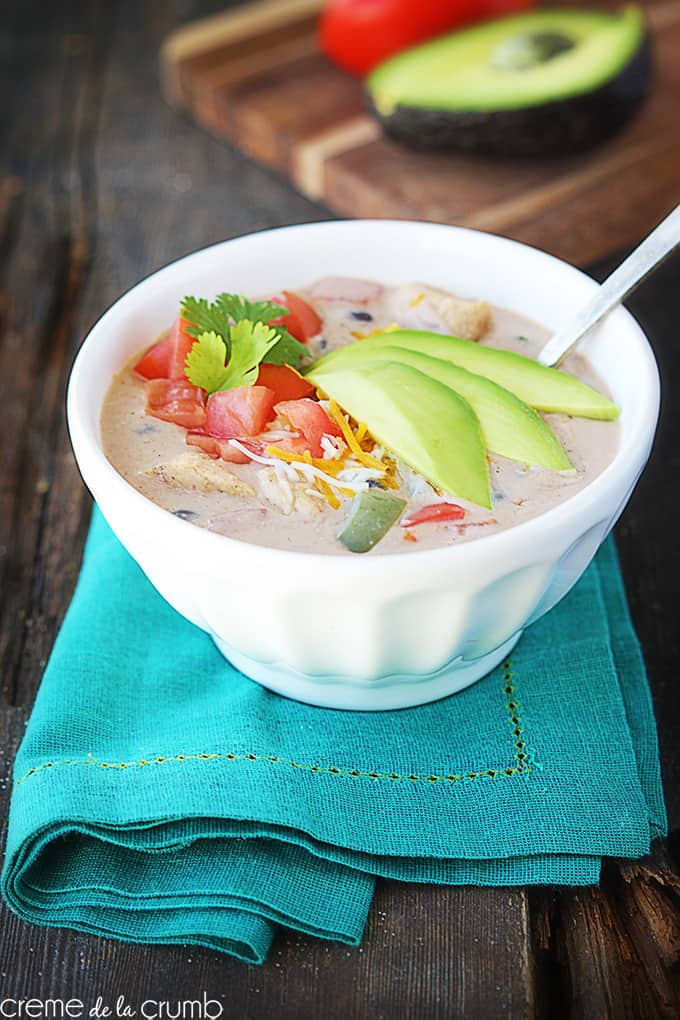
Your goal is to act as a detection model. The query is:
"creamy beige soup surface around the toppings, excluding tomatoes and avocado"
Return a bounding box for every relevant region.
[101,278,619,555]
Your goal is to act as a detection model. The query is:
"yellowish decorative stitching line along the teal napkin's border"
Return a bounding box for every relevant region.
[15,659,533,786]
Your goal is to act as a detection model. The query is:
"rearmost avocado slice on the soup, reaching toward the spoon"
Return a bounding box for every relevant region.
[308,329,619,420]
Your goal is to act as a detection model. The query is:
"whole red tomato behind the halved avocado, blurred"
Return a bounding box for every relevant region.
[319,0,534,74]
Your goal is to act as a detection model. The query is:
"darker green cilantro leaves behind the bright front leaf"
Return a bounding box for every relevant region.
[181,294,307,375]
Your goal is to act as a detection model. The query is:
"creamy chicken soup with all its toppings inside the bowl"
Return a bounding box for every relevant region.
[101,277,619,555]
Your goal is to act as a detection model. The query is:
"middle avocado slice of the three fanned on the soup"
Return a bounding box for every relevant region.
[314,343,572,471]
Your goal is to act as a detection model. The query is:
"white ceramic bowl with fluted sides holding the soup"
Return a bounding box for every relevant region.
[68,220,659,710]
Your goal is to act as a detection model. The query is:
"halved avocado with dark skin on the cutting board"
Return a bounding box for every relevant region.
[366,6,651,156]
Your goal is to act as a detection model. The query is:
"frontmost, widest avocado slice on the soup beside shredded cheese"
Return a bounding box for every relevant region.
[309,361,491,509]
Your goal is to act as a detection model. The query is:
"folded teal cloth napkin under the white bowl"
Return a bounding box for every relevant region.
[2,511,666,963]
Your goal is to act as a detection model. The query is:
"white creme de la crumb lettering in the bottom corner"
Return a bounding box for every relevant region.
[0,991,224,1020]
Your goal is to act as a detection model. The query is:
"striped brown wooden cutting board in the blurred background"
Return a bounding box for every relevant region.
[161,0,680,265]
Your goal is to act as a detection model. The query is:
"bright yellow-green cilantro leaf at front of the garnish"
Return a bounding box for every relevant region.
[185,319,279,394]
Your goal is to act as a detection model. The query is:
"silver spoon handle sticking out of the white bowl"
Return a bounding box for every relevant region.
[538,205,680,365]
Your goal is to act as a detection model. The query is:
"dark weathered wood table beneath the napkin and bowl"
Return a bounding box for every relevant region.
[0,0,680,1020]
